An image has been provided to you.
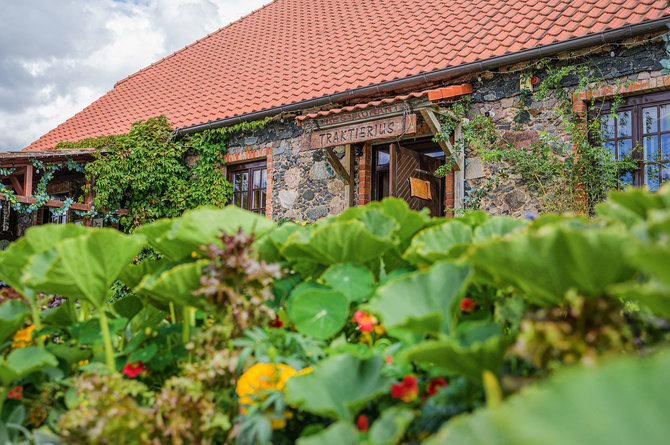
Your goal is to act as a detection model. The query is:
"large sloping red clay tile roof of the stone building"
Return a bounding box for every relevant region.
[27,0,670,150]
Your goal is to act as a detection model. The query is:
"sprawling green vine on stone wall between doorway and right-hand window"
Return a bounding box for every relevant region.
[435,61,640,213]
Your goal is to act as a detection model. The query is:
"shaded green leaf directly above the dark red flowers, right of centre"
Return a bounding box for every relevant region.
[405,336,505,382]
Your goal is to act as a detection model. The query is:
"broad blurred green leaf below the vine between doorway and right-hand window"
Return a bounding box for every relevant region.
[470,226,635,304]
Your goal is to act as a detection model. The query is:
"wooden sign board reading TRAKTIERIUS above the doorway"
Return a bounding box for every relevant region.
[311,114,416,149]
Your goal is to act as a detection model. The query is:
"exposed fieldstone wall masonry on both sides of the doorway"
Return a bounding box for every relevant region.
[228,36,668,222]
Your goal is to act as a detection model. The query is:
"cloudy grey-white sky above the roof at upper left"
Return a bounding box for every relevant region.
[0,0,270,151]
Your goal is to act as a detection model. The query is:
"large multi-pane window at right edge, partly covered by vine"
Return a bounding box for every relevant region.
[601,91,670,191]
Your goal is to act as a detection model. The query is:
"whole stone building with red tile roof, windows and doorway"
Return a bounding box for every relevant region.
[5,0,670,221]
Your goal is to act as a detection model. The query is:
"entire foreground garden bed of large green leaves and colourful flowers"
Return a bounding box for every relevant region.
[0,187,670,445]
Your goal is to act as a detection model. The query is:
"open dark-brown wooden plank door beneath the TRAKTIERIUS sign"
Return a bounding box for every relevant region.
[389,144,444,216]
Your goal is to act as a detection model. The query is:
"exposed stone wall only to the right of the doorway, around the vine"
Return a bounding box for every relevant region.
[461,35,668,217]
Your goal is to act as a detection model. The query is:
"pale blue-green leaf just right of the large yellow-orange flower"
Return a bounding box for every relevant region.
[286,354,392,421]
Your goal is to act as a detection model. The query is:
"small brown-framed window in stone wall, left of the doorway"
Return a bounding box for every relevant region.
[228,161,268,215]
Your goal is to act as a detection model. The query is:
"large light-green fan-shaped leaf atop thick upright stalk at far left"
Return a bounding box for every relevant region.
[23,229,146,308]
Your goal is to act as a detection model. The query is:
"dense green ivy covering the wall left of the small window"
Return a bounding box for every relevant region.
[56,112,268,231]
